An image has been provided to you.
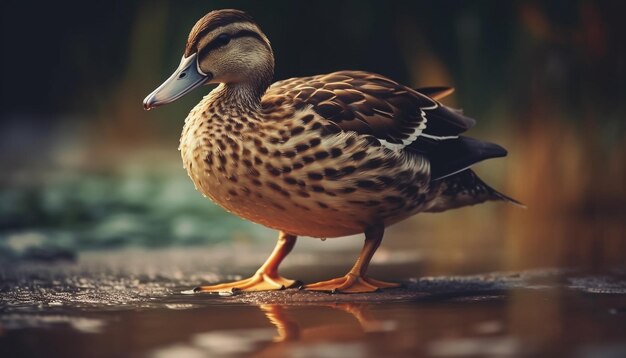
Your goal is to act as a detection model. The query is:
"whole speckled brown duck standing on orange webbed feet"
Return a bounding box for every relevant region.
[144,10,516,293]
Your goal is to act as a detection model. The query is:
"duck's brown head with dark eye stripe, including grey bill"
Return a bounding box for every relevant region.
[143,9,274,110]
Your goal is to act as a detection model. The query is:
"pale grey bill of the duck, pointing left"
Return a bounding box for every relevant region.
[143,53,212,110]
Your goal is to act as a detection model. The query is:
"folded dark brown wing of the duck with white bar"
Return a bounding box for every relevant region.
[262,71,506,179]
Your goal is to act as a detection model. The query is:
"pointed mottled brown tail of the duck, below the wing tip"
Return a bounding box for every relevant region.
[426,169,526,212]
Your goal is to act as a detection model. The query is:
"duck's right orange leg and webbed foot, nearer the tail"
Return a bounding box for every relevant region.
[304,225,400,293]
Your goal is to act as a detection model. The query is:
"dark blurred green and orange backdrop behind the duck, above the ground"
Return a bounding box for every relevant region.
[0,0,626,276]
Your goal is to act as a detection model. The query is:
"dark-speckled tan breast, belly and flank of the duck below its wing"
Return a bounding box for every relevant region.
[180,88,429,237]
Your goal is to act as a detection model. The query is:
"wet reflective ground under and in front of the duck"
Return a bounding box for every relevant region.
[0,248,626,357]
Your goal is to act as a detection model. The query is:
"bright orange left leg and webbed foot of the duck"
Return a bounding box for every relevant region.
[193,231,298,292]
